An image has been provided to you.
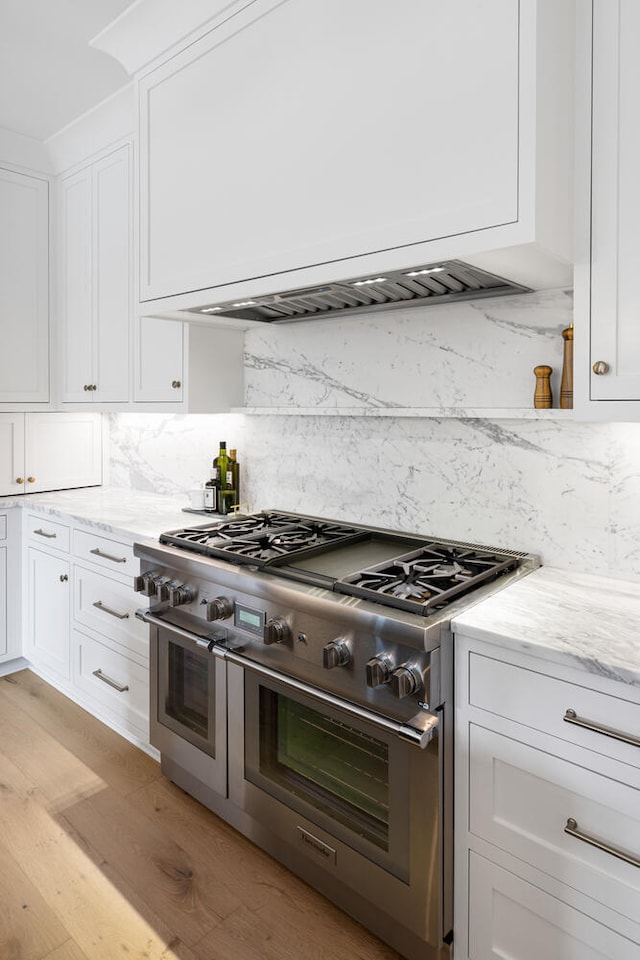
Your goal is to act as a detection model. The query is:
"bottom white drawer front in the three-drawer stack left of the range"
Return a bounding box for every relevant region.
[73,630,149,739]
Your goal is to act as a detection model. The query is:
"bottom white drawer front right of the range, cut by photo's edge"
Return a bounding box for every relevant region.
[464,853,640,960]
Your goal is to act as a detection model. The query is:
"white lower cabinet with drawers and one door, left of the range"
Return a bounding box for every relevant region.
[22,512,149,748]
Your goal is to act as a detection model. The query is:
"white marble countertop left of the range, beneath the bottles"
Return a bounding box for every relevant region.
[0,487,215,540]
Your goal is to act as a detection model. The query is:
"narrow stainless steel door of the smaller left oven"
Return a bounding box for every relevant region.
[146,615,227,805]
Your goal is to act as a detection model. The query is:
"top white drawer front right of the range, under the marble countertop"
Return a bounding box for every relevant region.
[469,653,640,768]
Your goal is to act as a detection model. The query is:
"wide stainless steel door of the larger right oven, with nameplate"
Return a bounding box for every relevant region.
[228,663,443,958]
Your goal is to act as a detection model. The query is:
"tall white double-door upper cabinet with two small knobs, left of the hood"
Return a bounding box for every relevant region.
[59,144,133,403]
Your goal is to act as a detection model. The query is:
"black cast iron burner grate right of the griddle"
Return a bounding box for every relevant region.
[334,545,518,615]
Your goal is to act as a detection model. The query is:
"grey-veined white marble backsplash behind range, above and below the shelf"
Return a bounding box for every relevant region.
[109,290,640,580]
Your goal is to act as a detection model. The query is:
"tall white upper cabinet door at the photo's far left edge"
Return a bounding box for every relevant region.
[0,168,49,403]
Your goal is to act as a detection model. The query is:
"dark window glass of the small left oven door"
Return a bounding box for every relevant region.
[165,641,210,740]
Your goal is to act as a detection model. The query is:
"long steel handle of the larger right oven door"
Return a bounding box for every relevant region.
[226,650,439,750]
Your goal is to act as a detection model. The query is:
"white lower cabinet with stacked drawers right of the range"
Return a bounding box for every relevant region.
[454,635,640,960]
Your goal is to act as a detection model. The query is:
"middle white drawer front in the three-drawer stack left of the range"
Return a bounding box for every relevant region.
[73,565,149,660]
